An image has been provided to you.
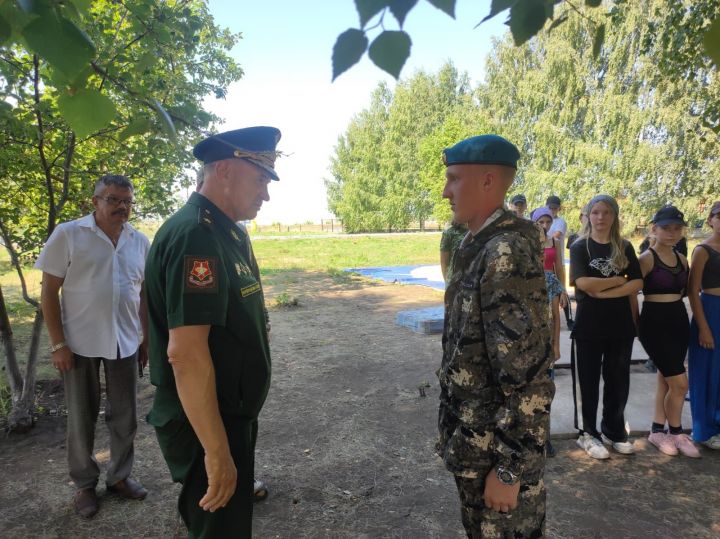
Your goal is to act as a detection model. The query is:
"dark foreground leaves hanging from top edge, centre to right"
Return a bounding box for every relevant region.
[332,0,720,84]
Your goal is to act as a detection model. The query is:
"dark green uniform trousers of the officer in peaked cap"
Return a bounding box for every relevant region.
[155,417,257,539]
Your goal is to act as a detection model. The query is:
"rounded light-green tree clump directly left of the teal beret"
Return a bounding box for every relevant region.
[326,64,472,232]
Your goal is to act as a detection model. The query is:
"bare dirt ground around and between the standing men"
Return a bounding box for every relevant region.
[0,272,720,539]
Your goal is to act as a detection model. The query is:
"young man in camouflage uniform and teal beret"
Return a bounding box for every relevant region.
[437,135,555,538]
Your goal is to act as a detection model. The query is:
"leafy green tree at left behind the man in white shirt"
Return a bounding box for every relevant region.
[0,0,242,430]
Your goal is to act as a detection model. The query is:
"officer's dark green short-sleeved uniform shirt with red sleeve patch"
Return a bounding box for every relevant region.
[145,193,270,426]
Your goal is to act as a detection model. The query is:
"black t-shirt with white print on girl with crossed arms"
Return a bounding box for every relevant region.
[570,238,642,339]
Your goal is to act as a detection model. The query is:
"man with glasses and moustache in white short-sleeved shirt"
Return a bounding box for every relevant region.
[35,175,150,518]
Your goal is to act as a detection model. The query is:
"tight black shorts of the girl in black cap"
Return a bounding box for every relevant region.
[639,300,690,378]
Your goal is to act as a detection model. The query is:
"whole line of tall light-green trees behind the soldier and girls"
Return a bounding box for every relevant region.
[326,0,720,232]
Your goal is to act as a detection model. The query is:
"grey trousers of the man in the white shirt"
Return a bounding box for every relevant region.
[63,352,138,489]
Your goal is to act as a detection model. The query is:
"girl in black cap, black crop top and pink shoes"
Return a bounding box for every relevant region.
[639,206,700,458]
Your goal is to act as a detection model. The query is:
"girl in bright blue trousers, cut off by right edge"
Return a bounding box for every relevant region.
[688,201,720,449]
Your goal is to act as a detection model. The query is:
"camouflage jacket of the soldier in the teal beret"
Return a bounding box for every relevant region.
[437,210,555,480]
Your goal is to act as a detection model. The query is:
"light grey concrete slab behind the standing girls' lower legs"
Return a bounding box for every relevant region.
[550,366,692,438]
